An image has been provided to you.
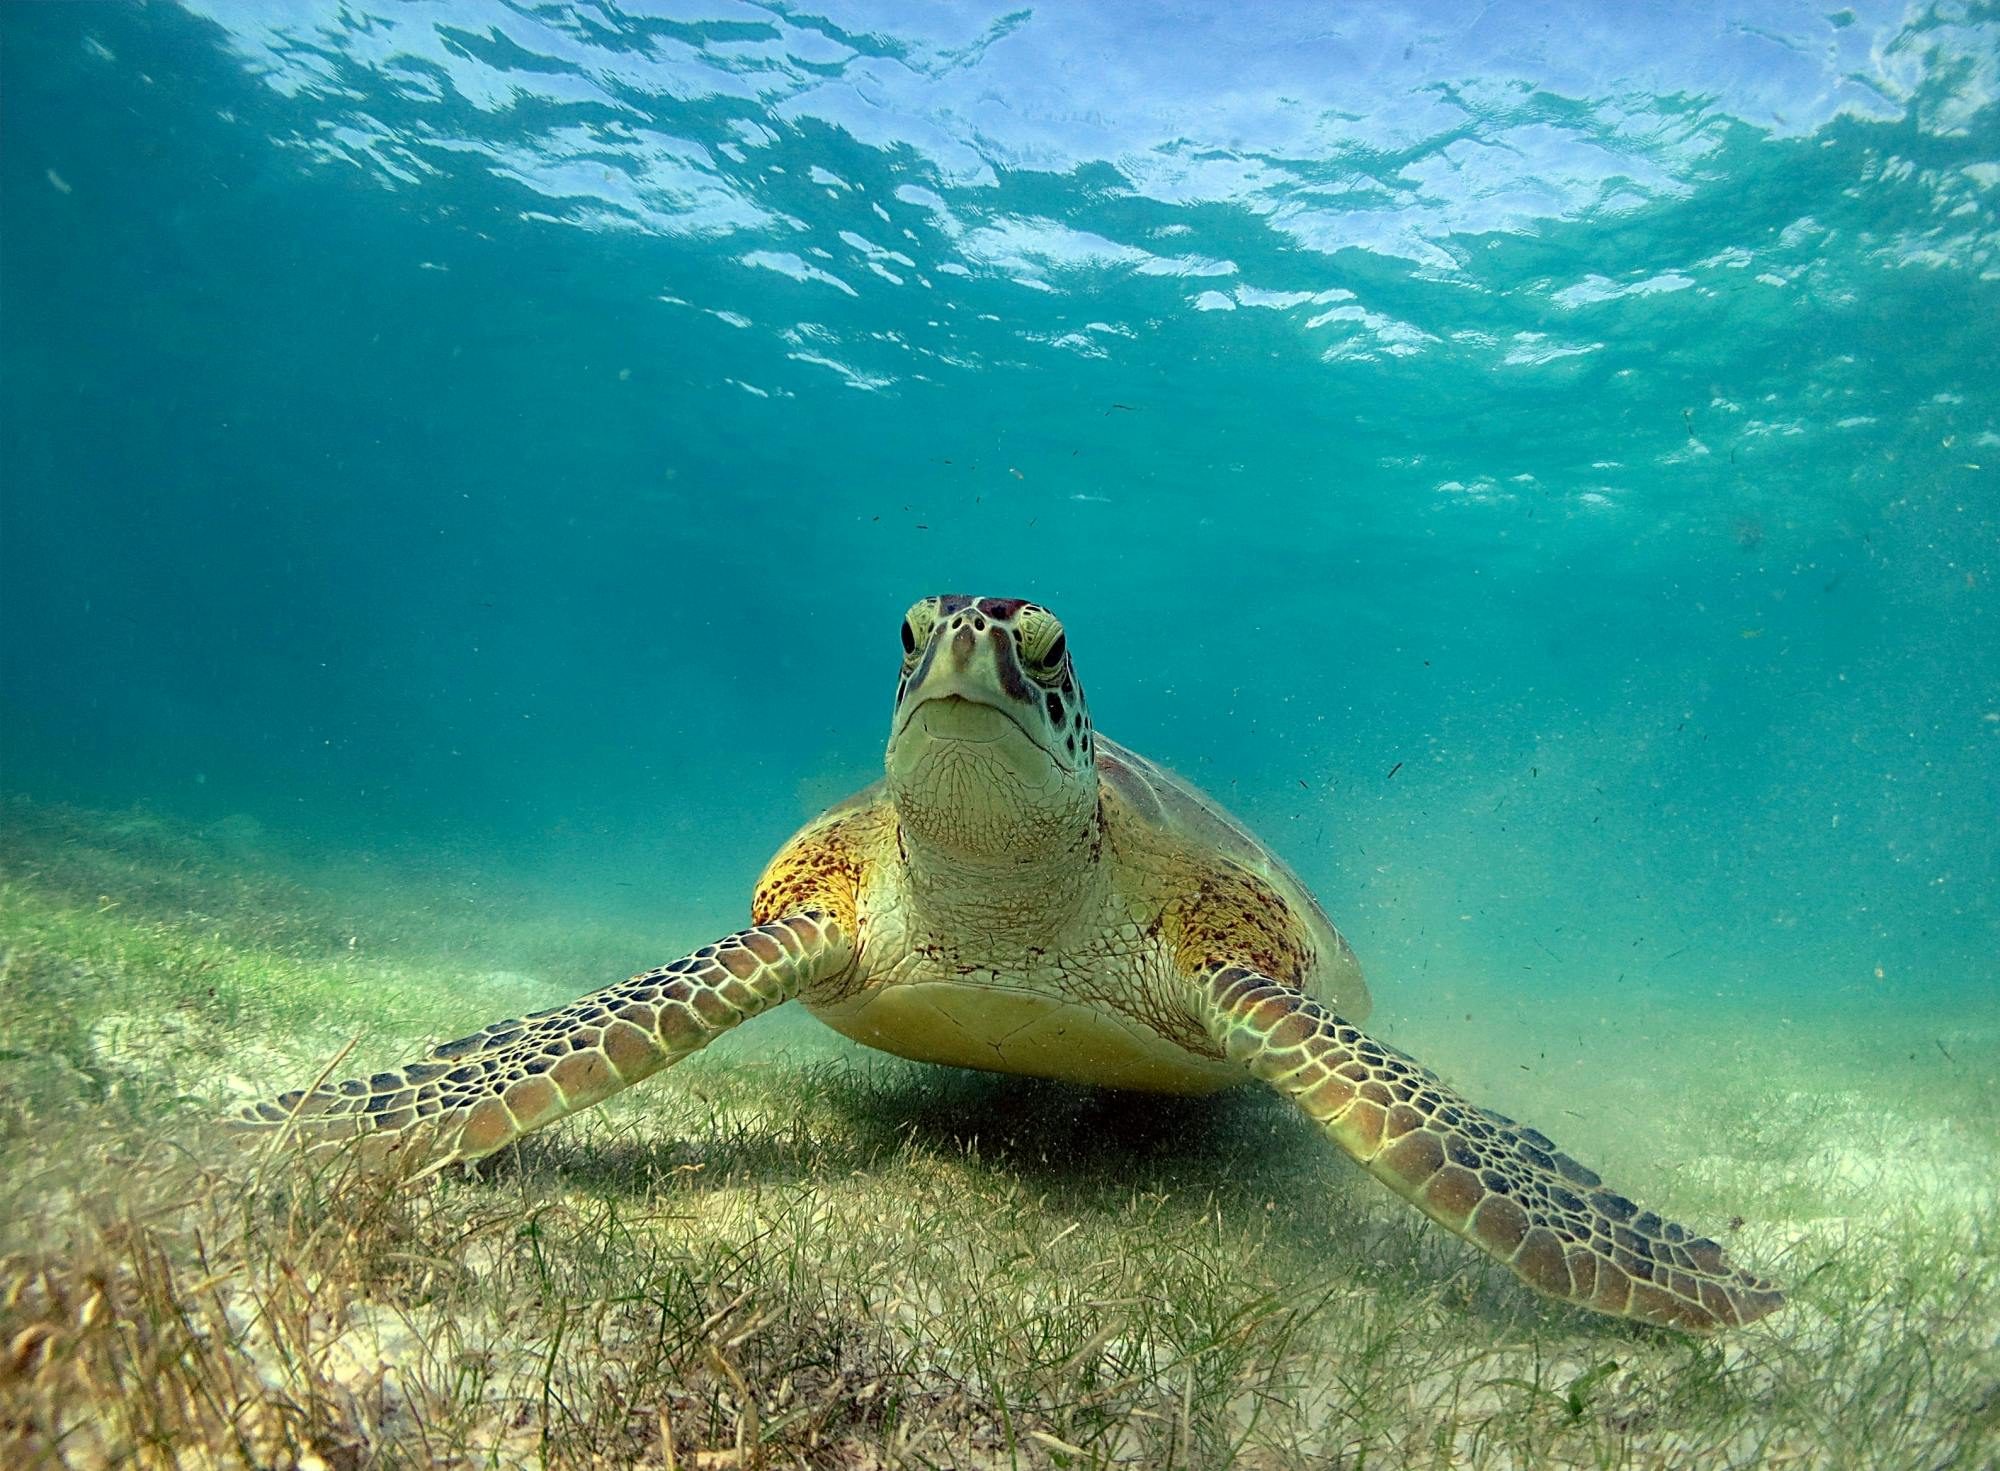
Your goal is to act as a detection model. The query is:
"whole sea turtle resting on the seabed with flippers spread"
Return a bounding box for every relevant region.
[244,596,1784,1331]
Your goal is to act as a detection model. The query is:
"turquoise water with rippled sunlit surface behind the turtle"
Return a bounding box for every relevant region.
[0,0,2000,1021]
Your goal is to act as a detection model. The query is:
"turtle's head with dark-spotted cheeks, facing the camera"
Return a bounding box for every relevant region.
[886,596,1098,863]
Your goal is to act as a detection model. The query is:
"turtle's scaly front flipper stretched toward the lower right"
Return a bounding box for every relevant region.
[1194,963,1784,1333]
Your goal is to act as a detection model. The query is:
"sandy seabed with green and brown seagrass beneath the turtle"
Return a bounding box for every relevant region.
[0,801,2000,1471]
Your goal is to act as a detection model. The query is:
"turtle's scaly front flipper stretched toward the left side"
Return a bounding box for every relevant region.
[238,909,854,1169]
